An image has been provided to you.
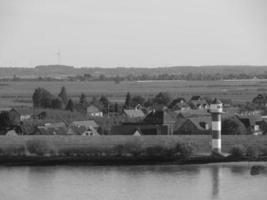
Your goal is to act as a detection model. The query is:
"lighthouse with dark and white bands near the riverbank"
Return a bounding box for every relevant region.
[210,98,223,153]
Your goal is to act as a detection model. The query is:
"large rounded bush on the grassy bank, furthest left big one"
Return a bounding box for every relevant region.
[26,140,57,156]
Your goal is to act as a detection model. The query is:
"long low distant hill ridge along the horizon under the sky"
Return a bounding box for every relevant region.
[0,65,267,78]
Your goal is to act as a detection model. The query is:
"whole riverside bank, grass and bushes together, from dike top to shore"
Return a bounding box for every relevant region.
[0,135,267,164]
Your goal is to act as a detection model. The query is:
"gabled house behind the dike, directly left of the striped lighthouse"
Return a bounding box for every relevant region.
[174,117,211,135]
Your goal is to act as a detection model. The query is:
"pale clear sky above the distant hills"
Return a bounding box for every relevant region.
[0,0,267,67]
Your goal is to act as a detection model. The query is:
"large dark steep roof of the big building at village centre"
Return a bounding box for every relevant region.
[143,110,177,124]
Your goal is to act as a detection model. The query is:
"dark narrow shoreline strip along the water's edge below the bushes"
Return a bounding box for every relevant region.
[0,156,267,166]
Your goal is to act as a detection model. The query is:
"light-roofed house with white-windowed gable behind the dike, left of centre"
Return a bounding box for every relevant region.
[68,120,99,135]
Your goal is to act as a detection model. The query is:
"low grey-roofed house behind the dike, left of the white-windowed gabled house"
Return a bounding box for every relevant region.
[34,122,68,135]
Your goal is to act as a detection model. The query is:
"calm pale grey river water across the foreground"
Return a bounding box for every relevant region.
[0,163,267,200]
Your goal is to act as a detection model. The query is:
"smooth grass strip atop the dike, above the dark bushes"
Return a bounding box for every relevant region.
[0,135,267,153]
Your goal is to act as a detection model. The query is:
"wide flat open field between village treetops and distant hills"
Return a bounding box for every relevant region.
[0,80,267,107]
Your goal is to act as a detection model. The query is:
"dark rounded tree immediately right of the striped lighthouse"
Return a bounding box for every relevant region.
[222,118,247,135]
